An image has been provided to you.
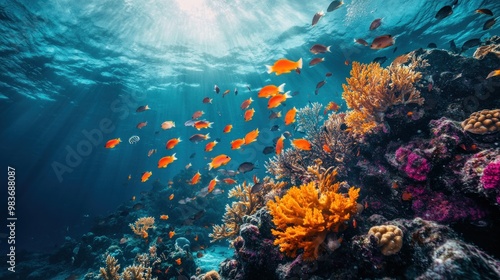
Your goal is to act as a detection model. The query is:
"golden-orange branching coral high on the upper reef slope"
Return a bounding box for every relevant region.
[342,56,425,135]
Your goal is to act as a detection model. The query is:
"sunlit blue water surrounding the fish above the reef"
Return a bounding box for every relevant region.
[0,0,500,253]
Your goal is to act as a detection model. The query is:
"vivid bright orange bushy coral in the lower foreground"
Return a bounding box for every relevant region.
[267,166,359,260]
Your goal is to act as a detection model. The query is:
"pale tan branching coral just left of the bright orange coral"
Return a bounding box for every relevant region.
[209,178,276,242]
